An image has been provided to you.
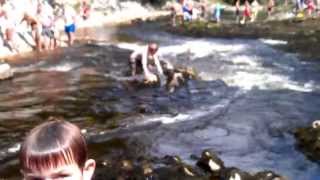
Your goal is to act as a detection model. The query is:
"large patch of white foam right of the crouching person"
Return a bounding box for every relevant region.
[155,38,316,92]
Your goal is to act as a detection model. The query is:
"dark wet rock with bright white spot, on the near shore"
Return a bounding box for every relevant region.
[197,150,225,176]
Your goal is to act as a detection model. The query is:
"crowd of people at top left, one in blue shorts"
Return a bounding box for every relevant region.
[0,0,90,52]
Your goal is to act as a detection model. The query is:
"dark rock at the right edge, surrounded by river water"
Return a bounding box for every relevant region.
[294,120,320,162]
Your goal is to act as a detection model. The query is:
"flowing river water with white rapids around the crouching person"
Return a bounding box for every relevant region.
[0,21,320,180]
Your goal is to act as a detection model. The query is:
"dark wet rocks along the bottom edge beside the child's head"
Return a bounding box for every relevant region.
[95,150,287,180]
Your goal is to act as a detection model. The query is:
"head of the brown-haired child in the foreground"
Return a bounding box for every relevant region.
[20,120,95,180]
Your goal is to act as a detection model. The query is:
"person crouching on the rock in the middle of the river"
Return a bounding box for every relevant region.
[130,43,163,83]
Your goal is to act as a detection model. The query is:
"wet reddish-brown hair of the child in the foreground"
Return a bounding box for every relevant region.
[20,119,87,171]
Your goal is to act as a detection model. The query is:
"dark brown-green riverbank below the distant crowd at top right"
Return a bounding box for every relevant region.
[167,15,320,60]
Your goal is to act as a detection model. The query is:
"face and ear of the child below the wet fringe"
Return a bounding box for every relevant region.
[23,160,95,180]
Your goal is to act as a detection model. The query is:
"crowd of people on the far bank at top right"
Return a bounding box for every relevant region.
[170,0,320,26]
